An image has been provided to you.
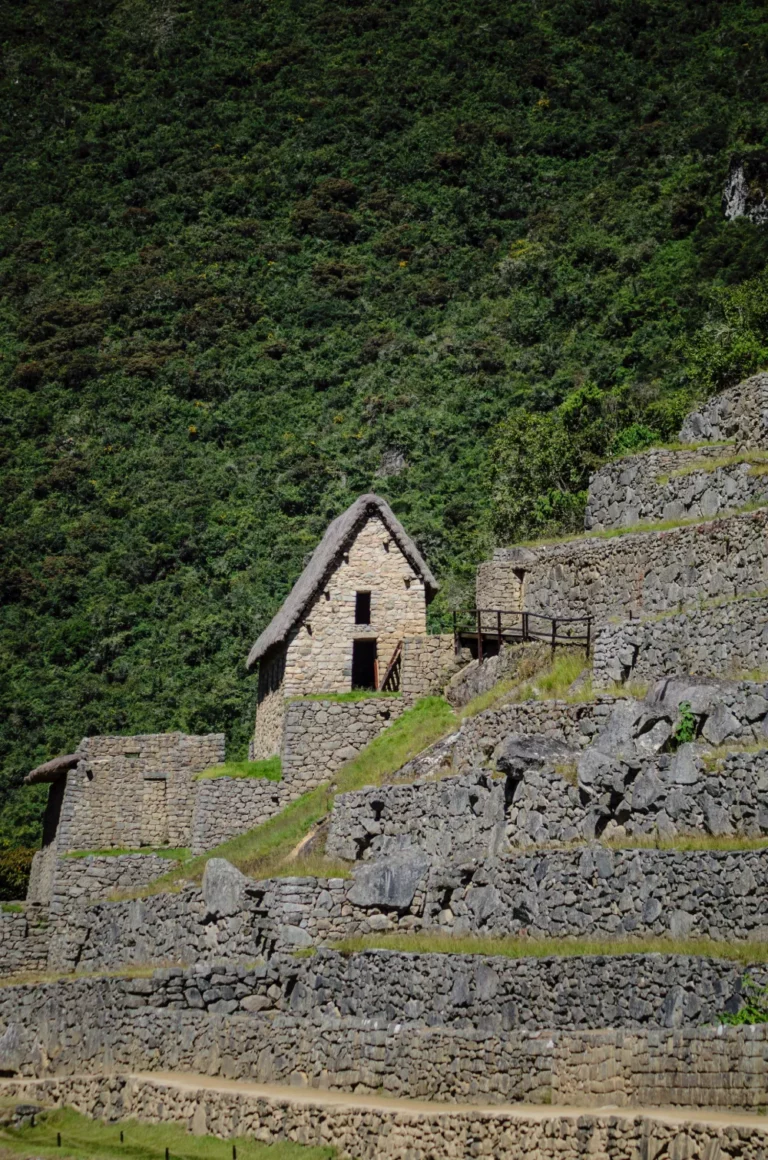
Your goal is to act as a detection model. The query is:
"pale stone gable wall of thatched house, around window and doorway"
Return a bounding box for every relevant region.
[284,516,427,697]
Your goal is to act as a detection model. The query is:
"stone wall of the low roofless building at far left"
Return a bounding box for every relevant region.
[56,733,224,854]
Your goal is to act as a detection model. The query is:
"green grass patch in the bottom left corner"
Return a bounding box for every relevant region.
[0,1108,336,1160]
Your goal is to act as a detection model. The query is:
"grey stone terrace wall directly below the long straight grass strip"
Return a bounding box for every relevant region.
[0,949,766,1048]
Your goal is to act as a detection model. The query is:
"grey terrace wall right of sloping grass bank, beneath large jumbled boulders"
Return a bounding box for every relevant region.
[326,746,768,864]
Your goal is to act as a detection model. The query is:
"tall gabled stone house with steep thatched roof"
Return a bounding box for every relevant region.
[247,494,437,760]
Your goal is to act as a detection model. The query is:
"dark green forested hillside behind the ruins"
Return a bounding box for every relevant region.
[0,0,768,844]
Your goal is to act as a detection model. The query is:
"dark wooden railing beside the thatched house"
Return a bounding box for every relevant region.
[454,608,593,662]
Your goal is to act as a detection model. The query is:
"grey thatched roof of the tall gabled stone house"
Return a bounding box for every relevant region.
[246,492,439,668]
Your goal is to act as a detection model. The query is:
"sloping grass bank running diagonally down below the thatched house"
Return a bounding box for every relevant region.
[135,697,458,898]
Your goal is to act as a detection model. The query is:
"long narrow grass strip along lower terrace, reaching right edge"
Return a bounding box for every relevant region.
[333,931,768,966]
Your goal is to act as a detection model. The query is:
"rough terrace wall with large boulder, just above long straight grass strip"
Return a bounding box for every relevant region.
[49,846,768,971]
